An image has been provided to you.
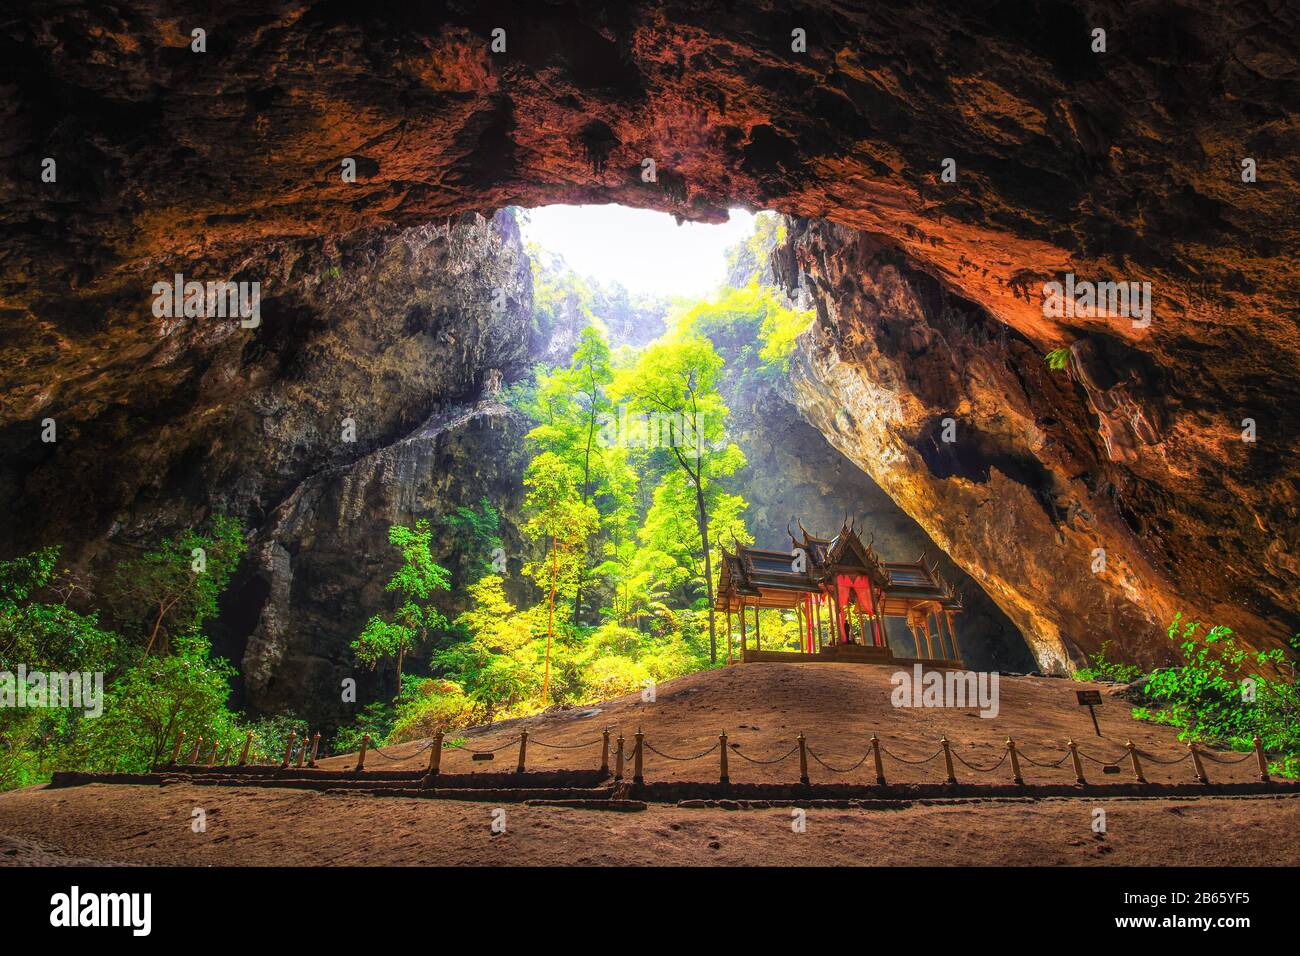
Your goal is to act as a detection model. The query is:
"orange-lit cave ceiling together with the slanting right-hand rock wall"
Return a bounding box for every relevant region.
[0,0,1300,661]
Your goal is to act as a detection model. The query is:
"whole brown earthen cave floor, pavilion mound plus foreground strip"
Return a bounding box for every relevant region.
[0,663,1300,866]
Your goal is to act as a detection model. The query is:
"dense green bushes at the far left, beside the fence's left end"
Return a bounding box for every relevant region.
[0,515,256,788]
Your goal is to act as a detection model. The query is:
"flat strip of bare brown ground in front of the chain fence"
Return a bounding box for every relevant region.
[0,784,1300,866]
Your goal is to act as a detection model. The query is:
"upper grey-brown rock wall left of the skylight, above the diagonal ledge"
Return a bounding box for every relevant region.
[0,212,532,559]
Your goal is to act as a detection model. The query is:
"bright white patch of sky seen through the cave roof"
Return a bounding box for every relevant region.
[523,206,754,297]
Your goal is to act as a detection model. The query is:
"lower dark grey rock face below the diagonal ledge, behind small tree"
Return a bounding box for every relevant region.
[235,399,529,727]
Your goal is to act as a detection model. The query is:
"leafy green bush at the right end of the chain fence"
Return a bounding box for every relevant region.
[1134,614,1300,777]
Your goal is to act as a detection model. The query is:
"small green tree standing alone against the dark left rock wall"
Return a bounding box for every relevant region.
[351,518,450,698]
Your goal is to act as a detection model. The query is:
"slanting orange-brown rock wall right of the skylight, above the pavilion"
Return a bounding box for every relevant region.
[781,222,1295,670]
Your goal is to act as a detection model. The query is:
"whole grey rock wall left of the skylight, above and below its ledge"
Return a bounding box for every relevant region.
[4,212,532,726]
